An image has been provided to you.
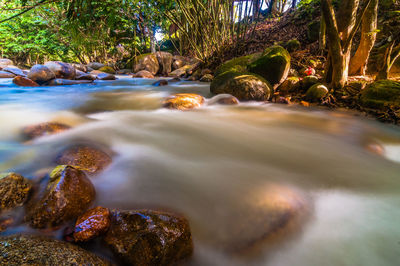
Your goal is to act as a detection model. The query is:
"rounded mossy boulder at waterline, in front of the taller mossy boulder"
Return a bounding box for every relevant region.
[210,71,273,101]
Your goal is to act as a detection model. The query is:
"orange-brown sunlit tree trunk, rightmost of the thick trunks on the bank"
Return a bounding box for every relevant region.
[349,0,379,75]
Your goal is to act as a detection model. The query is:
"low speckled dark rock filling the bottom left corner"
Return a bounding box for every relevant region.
[0,235,111,266]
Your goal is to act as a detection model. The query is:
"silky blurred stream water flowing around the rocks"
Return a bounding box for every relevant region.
[0,77,400,266]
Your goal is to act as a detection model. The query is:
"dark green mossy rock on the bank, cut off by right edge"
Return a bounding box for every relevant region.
[360,80,400,109]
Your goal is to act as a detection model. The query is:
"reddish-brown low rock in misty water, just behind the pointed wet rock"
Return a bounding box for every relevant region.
[56,144,112,173]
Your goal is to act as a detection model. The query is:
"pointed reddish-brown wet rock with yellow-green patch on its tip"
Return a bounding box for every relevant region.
[25,165,96,228]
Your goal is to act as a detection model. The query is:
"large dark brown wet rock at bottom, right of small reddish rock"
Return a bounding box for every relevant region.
[104,210,193,265]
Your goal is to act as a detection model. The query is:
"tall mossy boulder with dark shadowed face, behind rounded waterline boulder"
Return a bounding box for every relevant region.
[248,45,290,88]
